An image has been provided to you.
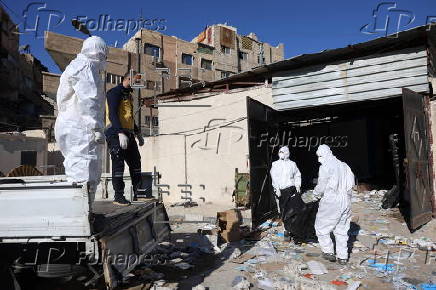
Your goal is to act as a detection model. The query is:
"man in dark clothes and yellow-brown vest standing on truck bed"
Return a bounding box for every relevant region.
[105,73,144,205]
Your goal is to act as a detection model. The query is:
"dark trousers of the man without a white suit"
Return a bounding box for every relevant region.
[106,134,141,197]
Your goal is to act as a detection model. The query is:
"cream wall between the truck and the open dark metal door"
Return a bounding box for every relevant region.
[140,86,272,206]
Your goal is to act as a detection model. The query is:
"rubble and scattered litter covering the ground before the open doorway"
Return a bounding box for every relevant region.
[120,190,436,290]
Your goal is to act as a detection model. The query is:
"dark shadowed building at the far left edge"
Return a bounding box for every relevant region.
[0,7,53,131]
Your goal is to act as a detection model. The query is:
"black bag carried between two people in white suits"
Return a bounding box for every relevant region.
[279,186,318,242]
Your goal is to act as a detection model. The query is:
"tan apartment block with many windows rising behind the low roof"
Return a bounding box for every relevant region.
[123,24,284,92]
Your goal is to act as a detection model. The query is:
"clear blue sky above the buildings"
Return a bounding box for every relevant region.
[0,0,436,73]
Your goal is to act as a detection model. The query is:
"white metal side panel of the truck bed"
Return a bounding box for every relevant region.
[0,181,90,238]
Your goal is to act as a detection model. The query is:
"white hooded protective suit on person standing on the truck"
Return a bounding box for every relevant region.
[55,36,107,188]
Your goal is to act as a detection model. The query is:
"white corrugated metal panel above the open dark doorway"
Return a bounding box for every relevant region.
[272,46,429,110]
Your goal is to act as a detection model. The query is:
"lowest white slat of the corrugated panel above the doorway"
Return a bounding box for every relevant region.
[273,83,429,110]
